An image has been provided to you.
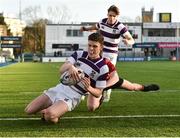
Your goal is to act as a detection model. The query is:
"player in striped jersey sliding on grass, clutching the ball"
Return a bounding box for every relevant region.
[25,33,109,123]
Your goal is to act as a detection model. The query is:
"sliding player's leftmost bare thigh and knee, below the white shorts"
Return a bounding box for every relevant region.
[25,94,52,114]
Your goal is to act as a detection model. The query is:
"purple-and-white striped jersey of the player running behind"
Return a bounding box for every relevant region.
[96,18,128,53]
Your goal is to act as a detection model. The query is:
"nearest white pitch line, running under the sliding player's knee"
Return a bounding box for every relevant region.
[0,115,180,121]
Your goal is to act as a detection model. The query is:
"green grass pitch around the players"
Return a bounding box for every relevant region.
[0,62,180,137]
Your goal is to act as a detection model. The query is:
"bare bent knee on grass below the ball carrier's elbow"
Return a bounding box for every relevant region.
[87,94,101,111]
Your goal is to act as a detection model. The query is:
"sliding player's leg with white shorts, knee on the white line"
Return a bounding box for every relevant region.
[41,84,81,123]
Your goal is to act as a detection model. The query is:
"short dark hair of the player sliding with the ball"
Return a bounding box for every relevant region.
[88,33,104,45]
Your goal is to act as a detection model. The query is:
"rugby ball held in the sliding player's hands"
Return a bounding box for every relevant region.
[60,69,85,86]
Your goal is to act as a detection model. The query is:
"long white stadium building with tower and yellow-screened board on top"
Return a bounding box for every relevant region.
[45,8,180,61]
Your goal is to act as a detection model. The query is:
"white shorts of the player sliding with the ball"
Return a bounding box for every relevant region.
[44,84,82,111]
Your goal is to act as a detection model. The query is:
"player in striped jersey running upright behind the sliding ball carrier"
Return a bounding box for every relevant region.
[80,5,134,102]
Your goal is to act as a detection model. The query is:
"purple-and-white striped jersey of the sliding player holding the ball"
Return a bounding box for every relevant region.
[67,51,109,94]
